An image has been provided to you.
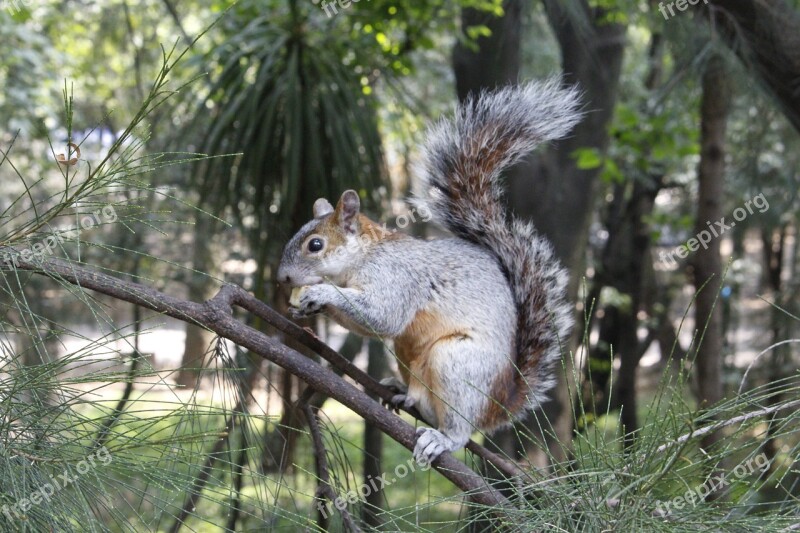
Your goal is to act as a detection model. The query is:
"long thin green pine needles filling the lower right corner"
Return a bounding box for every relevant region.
[500,298,800,531]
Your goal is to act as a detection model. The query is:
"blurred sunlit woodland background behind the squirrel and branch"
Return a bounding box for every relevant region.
[0,0,800,531]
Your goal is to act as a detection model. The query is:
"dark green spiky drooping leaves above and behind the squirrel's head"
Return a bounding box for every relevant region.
[191,2,385,271]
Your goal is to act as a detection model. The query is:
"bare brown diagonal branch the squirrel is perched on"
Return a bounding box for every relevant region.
[0,251,508,507]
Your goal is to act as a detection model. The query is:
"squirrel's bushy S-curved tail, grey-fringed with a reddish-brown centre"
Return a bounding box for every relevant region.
[416,79,581,420]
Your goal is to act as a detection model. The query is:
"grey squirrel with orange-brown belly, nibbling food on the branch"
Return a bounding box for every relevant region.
[278,79,582,464]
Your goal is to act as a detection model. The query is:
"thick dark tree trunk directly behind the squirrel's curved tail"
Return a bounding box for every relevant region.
[510,0,626,464]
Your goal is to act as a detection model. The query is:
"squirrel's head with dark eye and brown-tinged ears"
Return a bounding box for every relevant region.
[278,190,386,287]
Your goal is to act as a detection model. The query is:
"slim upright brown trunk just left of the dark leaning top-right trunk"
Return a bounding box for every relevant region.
[687,55,731,446]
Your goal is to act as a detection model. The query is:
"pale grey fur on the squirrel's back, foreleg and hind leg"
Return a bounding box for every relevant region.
[290,238,517,462]
